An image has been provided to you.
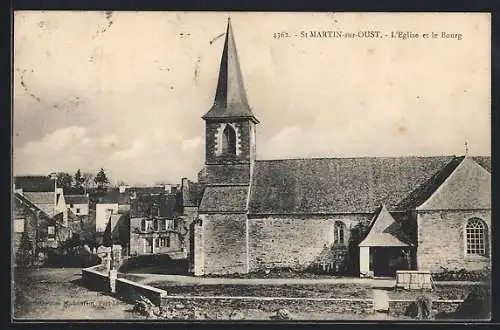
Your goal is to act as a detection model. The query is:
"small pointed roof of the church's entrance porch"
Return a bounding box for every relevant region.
[359,205,411,246]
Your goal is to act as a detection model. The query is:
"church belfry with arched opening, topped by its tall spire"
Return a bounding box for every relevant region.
[199,19,259,184]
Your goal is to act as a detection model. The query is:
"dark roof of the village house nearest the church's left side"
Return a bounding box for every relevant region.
[130,193,179,219]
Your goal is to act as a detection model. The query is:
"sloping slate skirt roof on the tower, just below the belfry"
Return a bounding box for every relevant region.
[198,185,248,213]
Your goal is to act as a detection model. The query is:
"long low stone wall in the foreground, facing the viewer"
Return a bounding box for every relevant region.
[161,296,373,314]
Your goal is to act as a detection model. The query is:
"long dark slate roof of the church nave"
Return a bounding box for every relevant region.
[249,156,488,214]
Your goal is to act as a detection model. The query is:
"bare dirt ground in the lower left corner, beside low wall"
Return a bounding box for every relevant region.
[12,268,145,320]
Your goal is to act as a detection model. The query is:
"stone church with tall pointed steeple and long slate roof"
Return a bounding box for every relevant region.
[190,20,491,276]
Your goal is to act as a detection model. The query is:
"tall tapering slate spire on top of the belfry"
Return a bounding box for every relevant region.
[202,16,259,123]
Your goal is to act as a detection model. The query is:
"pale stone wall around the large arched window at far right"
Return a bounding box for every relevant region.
[417,210,491,272]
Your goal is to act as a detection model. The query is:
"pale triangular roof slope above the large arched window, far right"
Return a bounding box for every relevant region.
[417,157,491,210]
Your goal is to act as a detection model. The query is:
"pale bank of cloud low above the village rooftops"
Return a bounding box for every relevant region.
[14,126,202,183]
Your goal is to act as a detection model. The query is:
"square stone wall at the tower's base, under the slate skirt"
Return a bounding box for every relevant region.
[195,214,248,275]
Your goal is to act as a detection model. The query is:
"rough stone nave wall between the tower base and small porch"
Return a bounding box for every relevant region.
[248,214,372,271]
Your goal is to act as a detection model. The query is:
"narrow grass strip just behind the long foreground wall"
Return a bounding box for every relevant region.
[149,282,372,299]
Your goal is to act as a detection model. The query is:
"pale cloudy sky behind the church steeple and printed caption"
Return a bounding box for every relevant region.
[13,11,491,184]
